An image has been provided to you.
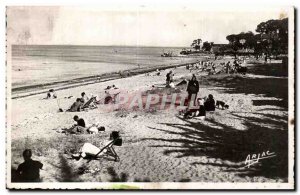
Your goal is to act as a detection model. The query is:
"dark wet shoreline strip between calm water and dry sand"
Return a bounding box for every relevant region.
[11,58,199,99]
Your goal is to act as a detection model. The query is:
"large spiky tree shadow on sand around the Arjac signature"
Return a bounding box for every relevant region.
[143,115,288,181]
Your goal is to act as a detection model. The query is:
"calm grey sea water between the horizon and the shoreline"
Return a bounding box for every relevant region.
[12,45,195,89]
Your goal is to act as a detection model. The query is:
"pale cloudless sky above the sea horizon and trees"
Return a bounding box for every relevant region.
[6,6,287,47]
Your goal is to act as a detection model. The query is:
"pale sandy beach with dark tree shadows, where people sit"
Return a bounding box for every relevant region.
[11,59,288,182]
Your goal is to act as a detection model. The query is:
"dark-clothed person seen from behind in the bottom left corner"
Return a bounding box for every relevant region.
[16,149,43,182]
